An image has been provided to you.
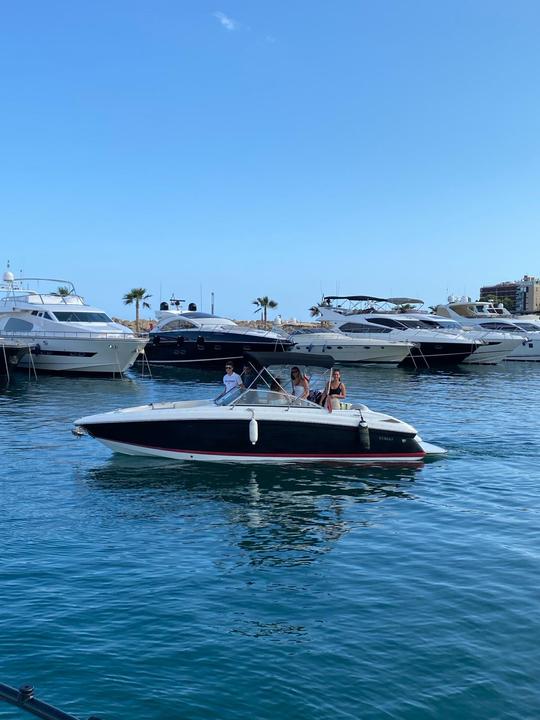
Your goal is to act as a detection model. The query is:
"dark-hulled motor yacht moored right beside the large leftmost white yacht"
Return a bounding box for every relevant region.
[140,303,293,369]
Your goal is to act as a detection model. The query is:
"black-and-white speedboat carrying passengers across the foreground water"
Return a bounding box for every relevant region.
[73,352,446,463]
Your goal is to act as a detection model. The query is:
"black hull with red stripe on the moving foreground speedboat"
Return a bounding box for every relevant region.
[77,412,425,462]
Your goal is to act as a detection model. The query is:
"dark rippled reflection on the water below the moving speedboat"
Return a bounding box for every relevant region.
[84,456,422,565]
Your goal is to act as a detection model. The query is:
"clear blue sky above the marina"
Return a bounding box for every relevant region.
[0,0,540,318]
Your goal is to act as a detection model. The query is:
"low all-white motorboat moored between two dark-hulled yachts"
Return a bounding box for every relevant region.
[289,327,414,365]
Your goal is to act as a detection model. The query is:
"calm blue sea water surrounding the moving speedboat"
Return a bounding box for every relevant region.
[0,364,540,720]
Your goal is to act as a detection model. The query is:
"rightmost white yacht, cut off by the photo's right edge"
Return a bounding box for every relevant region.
[435,295,540,362]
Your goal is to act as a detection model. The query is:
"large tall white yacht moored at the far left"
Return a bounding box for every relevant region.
[0,269,148,377]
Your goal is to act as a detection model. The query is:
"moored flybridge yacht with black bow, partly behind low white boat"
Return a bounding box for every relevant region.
[318,295,479,368]
